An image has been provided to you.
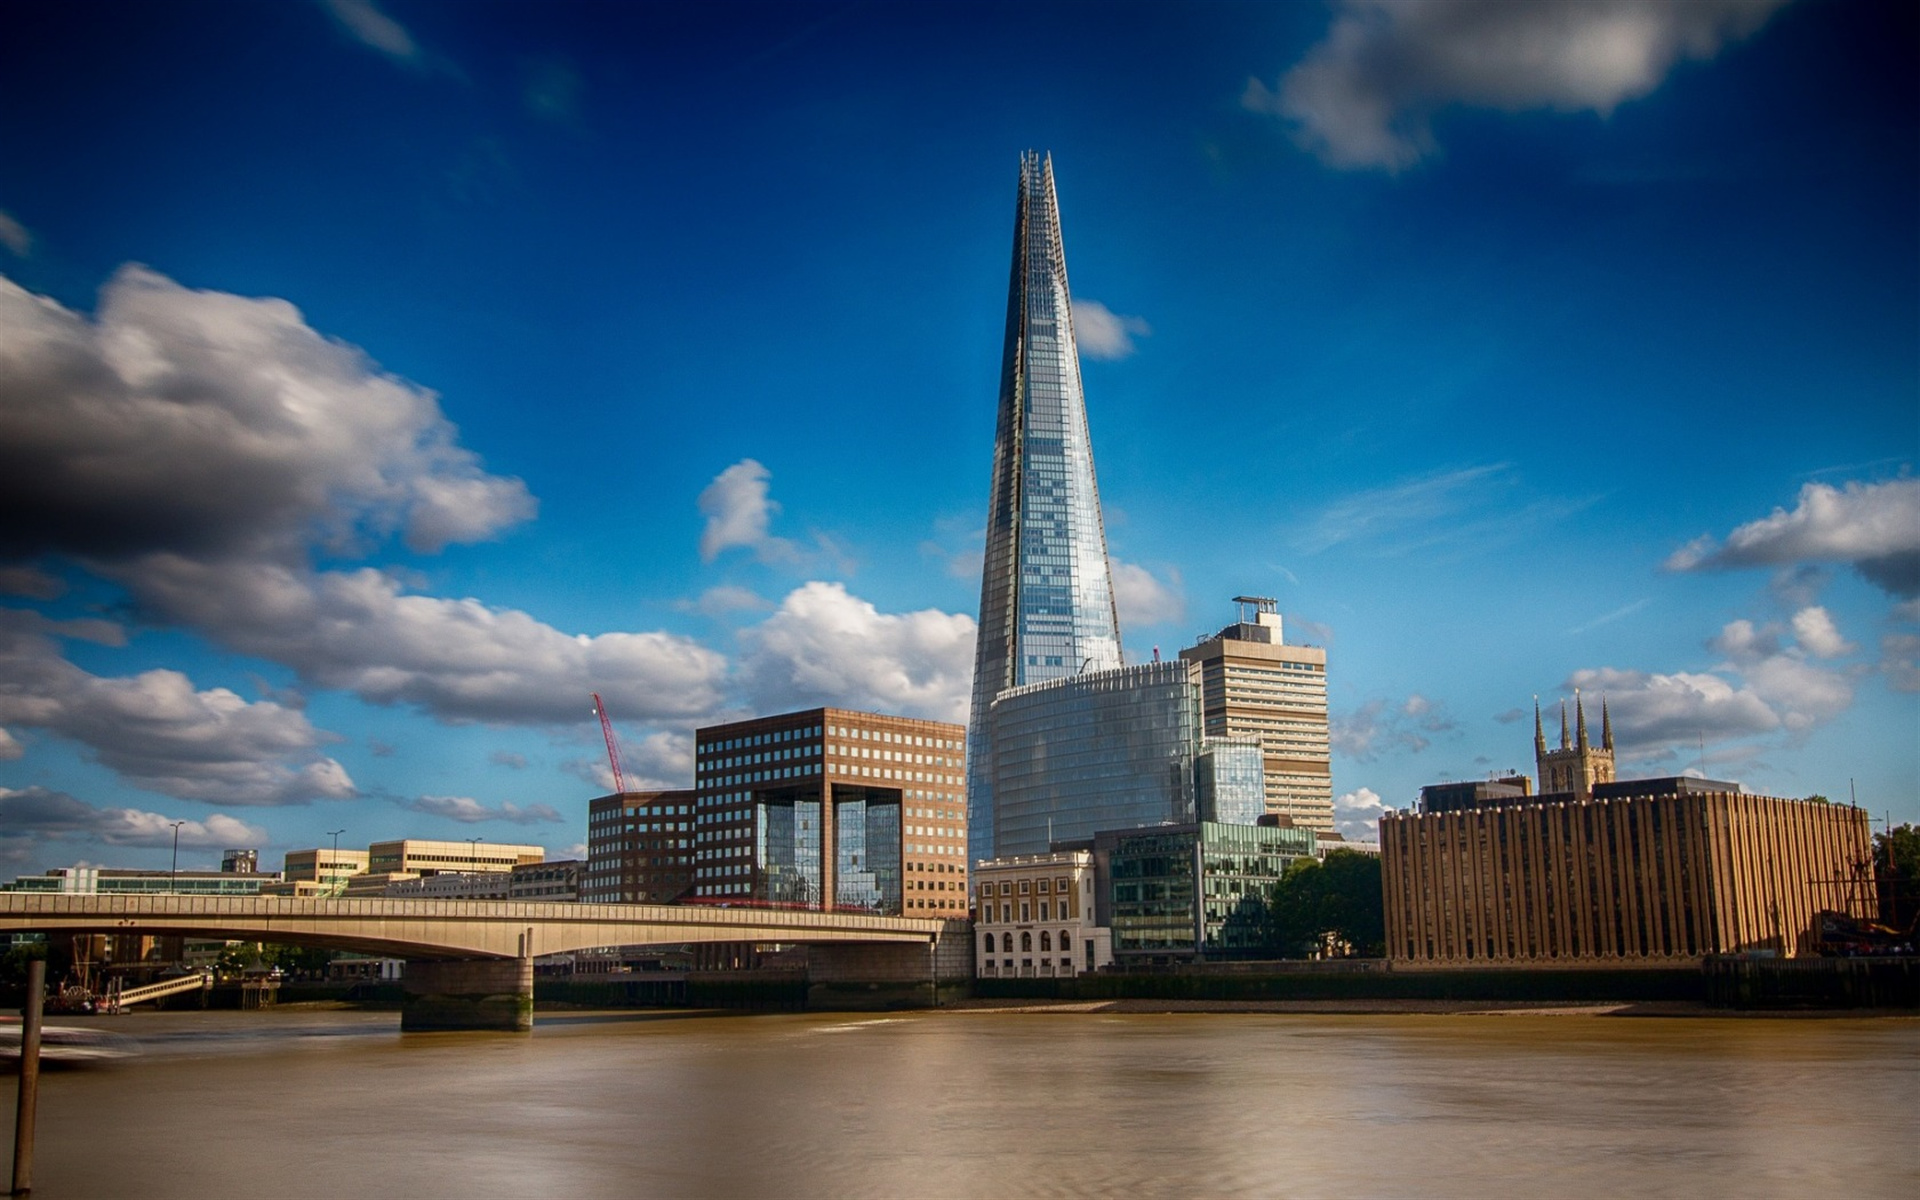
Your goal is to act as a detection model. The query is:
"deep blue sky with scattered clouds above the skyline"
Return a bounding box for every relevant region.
[0,0,1920,872]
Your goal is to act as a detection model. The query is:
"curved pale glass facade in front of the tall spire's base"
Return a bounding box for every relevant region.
[991,660,1200,856]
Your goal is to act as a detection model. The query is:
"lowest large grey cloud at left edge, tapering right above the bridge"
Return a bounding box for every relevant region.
[0,609,357,804]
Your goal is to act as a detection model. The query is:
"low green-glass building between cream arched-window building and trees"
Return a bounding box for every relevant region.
[1094,822,1315,962]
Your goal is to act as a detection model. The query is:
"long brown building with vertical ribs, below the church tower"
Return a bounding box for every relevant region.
[1380,780,1872,966]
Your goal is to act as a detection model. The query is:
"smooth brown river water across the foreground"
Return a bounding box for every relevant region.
[0,1010,1920,1200]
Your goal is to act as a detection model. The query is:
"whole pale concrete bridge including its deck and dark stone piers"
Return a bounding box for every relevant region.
[0,893,972,1029]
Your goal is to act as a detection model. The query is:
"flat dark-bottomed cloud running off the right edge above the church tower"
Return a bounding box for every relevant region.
[1667,478,1920,599]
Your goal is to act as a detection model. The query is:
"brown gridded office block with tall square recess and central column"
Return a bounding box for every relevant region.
[687,708,968,918]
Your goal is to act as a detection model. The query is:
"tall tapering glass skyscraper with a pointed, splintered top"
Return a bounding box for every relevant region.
[968,152,1121,862]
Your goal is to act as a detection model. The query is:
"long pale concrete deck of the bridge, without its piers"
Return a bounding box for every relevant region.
[0,893,950,960]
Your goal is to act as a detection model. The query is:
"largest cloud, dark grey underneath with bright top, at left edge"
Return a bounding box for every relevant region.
[0,265,534,561]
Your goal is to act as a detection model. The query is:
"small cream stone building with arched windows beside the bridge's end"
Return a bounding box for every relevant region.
[973,851,1114,979]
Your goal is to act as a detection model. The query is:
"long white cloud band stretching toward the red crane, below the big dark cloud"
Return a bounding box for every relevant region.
[109,555,726,724]
